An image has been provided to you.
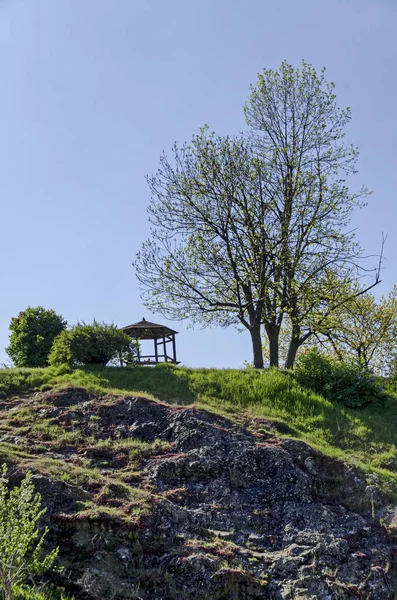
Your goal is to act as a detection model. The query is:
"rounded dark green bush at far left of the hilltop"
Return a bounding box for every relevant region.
[6,306,67,367]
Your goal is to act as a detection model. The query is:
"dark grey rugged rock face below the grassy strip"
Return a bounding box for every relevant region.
[10,390,397,600]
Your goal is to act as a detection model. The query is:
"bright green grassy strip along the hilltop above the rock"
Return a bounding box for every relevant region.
[0,366,397,497]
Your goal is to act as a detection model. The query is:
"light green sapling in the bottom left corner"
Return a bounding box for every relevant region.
[0,463,58,600]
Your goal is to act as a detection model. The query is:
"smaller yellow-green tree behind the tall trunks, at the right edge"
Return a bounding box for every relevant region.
[263,277,397,376]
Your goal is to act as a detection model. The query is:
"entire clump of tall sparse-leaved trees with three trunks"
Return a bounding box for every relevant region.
[134,62,378,368]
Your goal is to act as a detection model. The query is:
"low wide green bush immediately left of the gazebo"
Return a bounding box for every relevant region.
[49,321,134,367]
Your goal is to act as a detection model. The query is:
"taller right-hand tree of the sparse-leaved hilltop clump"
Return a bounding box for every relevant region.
[245,61,379,367]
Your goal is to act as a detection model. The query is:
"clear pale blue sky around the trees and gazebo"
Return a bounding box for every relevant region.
[0,0,397,368]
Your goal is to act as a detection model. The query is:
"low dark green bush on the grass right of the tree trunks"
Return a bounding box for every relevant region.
[294,349,384,408]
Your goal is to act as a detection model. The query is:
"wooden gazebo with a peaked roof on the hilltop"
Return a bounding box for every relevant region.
[121,319,179,365]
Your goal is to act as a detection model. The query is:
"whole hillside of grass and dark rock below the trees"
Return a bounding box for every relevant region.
[0,367,397,600]
